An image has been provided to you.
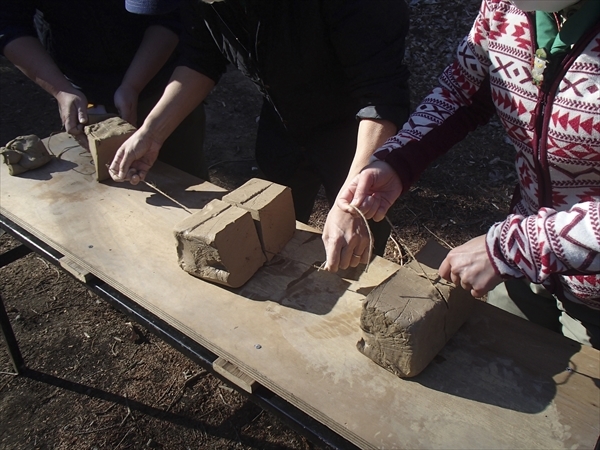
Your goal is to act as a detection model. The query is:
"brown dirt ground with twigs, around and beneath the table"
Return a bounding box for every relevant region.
[0,0,516,450]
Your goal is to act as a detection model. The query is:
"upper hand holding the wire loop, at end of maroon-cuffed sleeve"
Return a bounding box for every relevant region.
[336,161,402,222]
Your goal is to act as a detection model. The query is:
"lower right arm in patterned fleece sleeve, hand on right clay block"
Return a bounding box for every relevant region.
[439,202,600,306]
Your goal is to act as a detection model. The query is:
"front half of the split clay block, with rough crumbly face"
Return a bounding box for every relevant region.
[174,200,266,287]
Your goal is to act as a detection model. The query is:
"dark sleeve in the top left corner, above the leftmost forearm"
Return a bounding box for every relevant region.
[0,0,37,55]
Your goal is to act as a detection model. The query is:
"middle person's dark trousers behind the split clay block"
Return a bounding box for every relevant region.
[256,102,390,255]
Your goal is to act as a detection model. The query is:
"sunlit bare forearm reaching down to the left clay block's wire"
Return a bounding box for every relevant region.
[140,66,215,145]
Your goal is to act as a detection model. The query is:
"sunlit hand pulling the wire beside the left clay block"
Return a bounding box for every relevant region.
[108,128,162,185]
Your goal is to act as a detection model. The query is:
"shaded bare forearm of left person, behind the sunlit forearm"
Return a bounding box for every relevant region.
[122,25,179,94]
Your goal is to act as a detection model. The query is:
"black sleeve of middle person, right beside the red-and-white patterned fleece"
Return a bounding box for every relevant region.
[323,0,410,128]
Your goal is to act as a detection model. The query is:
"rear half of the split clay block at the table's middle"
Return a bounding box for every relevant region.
[223,178,296,261]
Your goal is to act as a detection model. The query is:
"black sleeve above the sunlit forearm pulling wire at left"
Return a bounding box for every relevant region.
[177,1,228,83]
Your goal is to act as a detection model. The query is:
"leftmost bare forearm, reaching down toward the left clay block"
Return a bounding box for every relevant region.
[4,36,75,97]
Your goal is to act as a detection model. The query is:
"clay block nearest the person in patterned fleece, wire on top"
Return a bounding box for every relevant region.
[357,242,476,377]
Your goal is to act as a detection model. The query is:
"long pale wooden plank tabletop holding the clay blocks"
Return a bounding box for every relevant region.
[0,134,600,448]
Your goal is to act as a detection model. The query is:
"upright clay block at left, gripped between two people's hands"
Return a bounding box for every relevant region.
[85,117,136,181]
